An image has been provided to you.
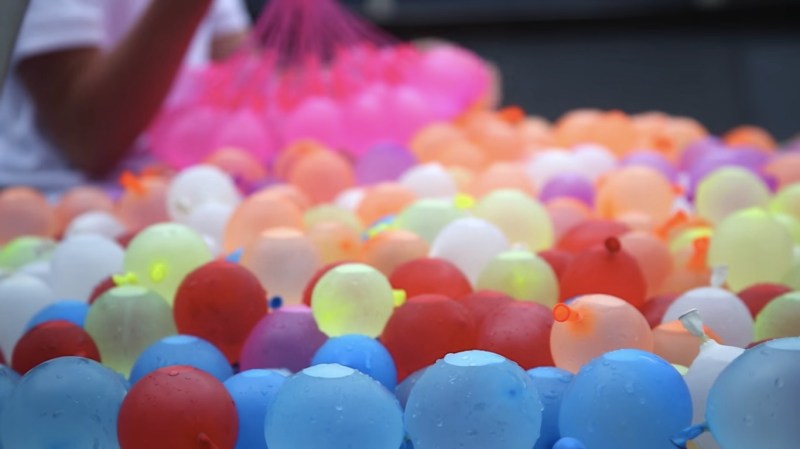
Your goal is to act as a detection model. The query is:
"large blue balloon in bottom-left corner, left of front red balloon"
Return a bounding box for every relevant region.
[0,357,126,449]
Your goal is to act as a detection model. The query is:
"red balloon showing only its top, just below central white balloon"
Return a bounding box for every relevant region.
[389,258,472,298]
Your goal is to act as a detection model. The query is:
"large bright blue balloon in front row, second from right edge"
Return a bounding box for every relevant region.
[559,349,692,449]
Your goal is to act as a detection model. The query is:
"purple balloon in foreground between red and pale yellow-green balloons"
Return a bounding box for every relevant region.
[240,305,328,372]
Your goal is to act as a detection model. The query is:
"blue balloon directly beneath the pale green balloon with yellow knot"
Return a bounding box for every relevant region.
[311,334,397,391]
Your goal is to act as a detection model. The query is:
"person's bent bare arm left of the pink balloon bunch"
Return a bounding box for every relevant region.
[17,0,211,177]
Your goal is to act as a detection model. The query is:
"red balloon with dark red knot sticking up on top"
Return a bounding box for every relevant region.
[560,237,647,308]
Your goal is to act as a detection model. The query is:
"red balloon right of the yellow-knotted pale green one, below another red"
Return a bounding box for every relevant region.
[380,295,476,381]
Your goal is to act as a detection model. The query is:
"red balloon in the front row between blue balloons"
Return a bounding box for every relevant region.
[117,366,239,449]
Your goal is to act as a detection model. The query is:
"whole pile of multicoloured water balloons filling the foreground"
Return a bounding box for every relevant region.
[0,102,800,449]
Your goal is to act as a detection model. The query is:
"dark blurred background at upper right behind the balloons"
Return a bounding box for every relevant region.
[248,0,800,139]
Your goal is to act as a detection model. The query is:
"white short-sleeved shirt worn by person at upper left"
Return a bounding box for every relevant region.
[0,0,248,192]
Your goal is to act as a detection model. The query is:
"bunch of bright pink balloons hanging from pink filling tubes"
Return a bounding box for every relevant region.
[150,0,493,168]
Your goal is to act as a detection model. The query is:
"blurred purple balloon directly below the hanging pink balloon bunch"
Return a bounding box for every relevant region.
[355,143,417,185]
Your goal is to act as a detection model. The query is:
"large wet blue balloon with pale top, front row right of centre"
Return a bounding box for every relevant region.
[405,351,543,449]
